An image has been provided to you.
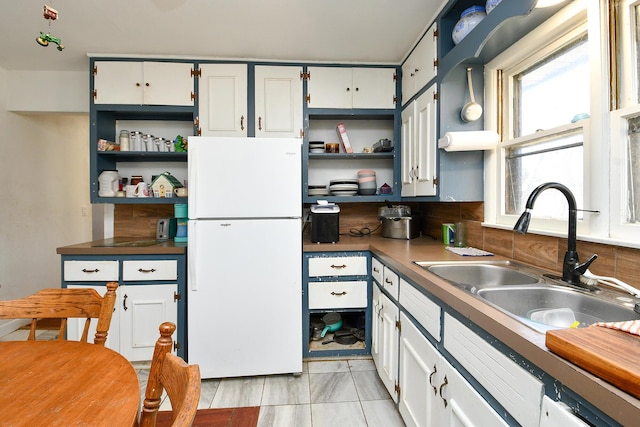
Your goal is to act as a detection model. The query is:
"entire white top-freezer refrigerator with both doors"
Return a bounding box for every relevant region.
[187,137,302,378]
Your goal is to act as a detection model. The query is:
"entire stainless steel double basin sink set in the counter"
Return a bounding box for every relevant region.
[415,260,640,333]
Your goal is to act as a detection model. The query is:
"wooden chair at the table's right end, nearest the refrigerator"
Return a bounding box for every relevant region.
[140,322,200,427]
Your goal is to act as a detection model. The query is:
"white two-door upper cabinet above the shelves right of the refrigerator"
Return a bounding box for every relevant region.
[307,67,397,109]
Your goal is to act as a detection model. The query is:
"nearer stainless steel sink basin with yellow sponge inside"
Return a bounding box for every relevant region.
[476,284,640,331]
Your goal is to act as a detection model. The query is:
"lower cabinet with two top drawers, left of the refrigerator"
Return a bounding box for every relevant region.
[62,255,186,361]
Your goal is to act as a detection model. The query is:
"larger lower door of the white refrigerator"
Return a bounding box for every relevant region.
[187,219,302,378]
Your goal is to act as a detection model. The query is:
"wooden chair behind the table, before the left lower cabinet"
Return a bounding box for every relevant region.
[0,282,118,346]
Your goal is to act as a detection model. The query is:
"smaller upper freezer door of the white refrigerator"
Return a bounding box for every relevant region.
[189,137,302,219]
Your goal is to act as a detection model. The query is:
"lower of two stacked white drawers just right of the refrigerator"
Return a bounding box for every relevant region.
[309,281,367,309]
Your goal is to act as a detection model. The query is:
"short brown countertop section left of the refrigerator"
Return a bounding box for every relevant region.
[56,237,187,255]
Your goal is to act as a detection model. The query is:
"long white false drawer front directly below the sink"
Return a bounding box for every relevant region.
[444,313,544,427]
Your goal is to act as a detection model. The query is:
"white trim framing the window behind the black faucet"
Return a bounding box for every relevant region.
[483,0,611,243]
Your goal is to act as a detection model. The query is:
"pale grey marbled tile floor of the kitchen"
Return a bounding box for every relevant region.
[0,330,405,427]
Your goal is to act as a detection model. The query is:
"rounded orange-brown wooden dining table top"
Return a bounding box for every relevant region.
[0,341,140,427]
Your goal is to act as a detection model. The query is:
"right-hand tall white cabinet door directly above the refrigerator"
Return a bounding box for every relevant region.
[255,66,303,138]
